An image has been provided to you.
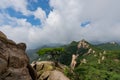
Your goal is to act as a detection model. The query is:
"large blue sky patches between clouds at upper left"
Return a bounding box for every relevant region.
[0,0,52,25]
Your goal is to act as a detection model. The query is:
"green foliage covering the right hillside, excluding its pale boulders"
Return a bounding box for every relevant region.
[62,41,120,80]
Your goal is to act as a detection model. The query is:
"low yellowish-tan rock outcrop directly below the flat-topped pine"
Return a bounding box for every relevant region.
[31,61,70,80]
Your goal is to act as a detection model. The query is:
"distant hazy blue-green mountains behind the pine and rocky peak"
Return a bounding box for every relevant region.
[27,41,120,62]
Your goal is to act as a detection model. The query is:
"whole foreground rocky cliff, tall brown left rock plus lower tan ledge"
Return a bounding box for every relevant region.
[0,31,70,80]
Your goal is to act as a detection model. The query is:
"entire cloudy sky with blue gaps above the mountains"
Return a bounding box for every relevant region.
[0,0,120,49]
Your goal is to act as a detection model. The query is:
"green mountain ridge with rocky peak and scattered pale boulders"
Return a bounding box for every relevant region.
[35,40,120,80]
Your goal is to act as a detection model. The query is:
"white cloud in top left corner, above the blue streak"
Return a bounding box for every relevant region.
[0,0,31,15]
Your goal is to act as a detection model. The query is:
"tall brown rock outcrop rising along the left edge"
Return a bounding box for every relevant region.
[0,31,37,80]
